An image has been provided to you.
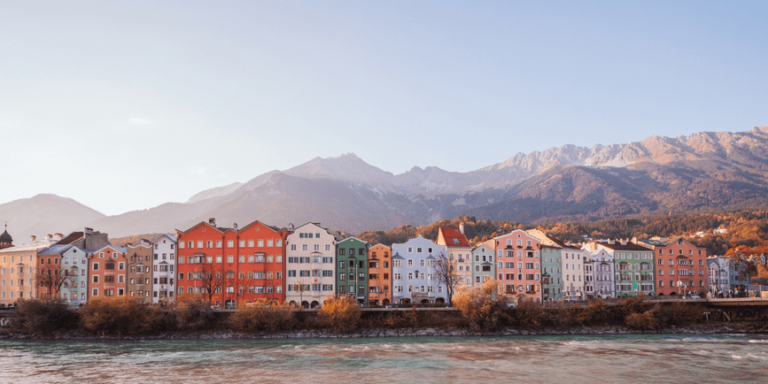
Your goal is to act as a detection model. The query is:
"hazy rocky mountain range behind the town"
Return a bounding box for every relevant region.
[0,127,768,243]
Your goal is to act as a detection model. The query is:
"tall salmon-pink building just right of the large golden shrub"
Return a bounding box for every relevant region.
[494,229,541,302]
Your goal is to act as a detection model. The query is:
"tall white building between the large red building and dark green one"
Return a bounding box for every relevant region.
[285,223,336,308]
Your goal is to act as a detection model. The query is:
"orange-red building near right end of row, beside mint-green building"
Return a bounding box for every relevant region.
[638,237,707,296]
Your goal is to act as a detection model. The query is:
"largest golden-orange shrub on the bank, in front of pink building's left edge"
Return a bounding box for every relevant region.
[451,279,509,331]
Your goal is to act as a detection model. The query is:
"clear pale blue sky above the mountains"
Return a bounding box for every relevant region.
[0,0,768,215]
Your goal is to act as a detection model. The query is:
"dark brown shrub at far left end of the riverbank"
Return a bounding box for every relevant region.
[11,299,79,334]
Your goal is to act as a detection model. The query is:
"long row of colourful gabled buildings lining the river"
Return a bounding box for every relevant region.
[0,218,752,307]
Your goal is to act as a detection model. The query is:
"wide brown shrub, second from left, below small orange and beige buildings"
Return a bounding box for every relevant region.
[80,296,150,335]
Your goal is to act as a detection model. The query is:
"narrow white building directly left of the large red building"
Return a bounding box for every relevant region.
[152,234,178,304]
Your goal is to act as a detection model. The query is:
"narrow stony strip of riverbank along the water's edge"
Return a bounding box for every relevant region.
[0,323,768,341]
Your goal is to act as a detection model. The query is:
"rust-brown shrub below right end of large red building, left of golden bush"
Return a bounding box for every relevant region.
[229,304,296,332]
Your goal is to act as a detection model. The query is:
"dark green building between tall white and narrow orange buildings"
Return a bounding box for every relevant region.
[336,237,368,305]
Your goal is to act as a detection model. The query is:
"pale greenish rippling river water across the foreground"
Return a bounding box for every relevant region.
[0,335,768,383]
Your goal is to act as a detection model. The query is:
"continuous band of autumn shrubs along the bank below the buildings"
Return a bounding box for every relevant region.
[0,284,768,340]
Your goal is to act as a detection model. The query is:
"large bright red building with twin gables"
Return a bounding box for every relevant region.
[177,218,288,308]
